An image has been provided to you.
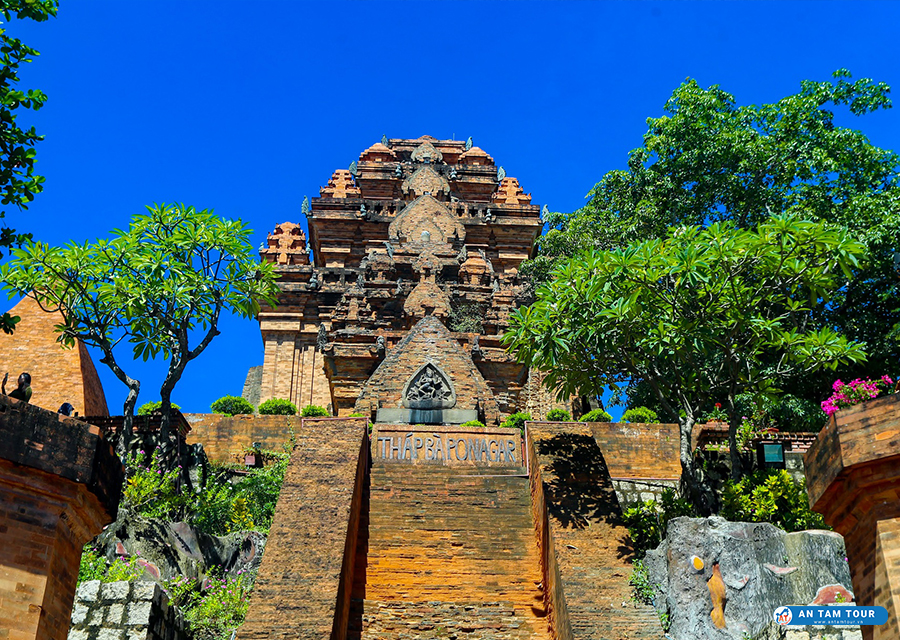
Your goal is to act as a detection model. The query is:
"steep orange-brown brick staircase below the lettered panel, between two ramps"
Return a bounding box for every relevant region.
[348,463,550,640]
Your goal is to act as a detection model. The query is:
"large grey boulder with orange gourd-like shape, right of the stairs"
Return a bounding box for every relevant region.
[646,516,853,640]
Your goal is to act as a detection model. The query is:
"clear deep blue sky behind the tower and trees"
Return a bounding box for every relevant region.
[1,0,900,413]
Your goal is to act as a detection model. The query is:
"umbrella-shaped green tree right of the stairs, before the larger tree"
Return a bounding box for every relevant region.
[504,215,865,504]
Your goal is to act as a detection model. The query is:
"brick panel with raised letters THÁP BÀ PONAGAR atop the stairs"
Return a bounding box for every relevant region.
[372,425,525,467]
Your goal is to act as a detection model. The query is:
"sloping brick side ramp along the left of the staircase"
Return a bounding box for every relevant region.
[238,418,368,640]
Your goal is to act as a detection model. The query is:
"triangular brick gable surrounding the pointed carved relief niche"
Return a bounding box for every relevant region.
[356,316,500,424]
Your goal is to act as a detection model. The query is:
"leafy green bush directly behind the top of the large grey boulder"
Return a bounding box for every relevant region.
[719,469,830,532]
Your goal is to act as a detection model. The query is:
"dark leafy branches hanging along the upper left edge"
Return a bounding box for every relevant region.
[0,0,59,333]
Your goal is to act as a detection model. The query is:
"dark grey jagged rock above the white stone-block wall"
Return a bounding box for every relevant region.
[97,509,266,582]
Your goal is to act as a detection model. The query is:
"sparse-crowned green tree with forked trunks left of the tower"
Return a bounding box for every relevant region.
[0,204,277,453]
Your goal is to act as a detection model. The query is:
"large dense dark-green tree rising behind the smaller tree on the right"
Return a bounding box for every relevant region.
[524,69,900,388]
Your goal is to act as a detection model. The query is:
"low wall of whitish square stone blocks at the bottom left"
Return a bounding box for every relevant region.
[68,580,190,640]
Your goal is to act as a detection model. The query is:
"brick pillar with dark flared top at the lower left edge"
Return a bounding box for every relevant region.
[0,396,123,640]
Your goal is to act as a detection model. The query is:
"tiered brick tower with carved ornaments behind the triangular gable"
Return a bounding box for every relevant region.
[259,136,542,422]
